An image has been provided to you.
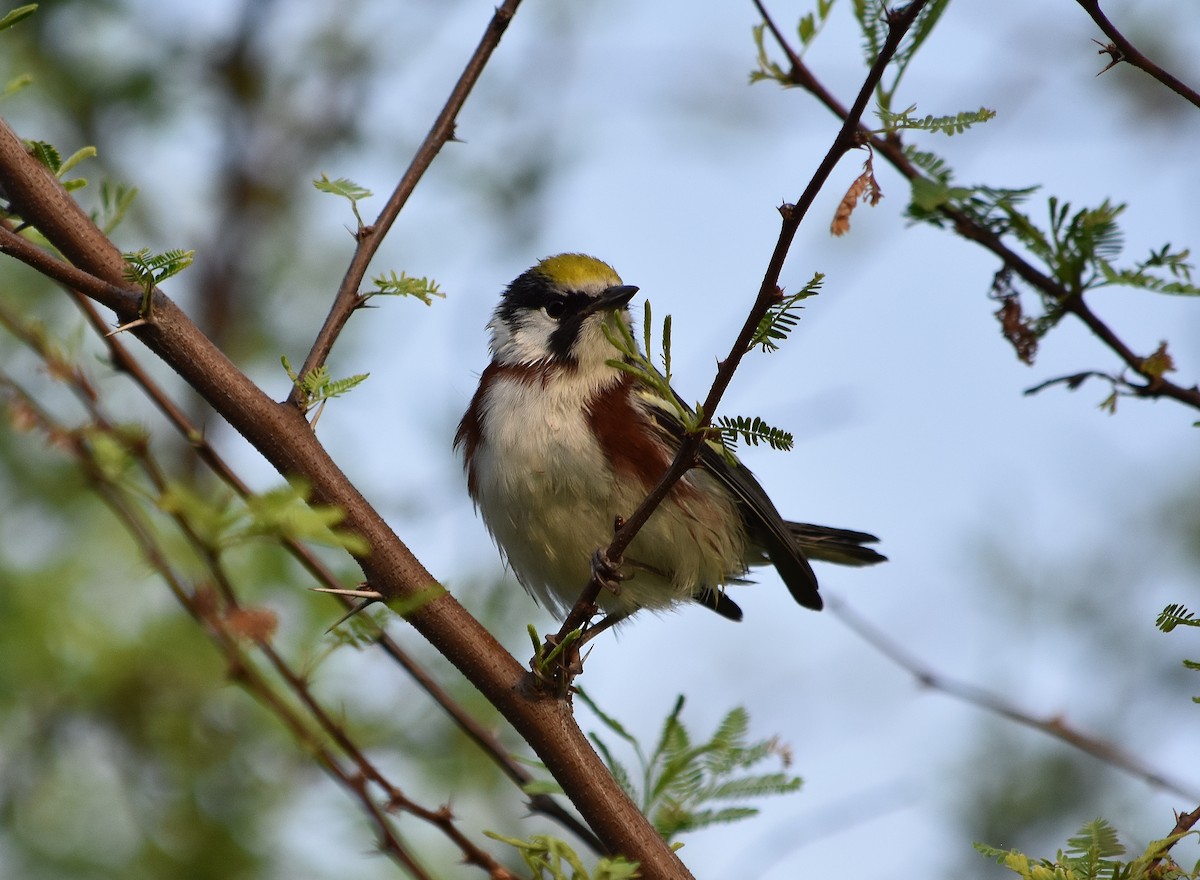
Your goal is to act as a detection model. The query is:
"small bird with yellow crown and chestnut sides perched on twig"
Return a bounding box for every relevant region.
[455,253,886,621]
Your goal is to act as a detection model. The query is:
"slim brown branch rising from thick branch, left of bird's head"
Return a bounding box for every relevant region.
[288,0,521,407]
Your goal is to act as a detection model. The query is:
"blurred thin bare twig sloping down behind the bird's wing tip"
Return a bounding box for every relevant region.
[826,599,1200,800]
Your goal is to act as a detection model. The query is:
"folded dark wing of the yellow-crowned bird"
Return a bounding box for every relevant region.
[636,390,824,610]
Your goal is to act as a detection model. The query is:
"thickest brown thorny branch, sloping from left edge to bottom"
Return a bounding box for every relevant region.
[0,115,690,878]
